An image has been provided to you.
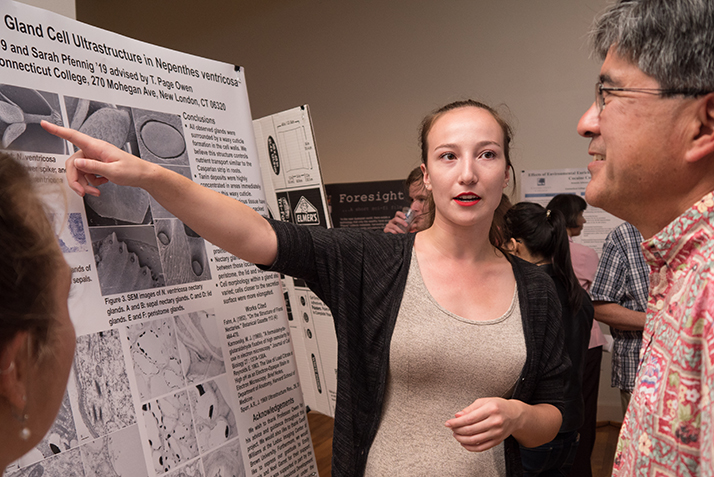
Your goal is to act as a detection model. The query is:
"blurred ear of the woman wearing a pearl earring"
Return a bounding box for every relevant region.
[0,331,32,411]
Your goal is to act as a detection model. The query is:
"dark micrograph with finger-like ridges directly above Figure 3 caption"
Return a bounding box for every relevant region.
[89,226,166,295]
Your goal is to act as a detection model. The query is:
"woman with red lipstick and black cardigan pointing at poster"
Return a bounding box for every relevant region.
[43,101,569,476]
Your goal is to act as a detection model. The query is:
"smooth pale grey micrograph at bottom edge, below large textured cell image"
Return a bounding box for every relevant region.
[80,426,148,477]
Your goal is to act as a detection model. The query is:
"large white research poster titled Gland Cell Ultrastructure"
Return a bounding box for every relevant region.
[0,0,322,477]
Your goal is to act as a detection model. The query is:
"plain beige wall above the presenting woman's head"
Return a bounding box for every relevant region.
[76,0,607,191]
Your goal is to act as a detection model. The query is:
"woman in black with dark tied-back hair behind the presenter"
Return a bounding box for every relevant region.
[505,202,594,477]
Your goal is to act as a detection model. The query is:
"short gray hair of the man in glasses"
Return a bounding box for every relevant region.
[592,0,714,95]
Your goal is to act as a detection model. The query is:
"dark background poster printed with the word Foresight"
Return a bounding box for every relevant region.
[325,180,411,230]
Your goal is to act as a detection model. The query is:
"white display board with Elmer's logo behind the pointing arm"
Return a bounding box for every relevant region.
[253,105,337,417]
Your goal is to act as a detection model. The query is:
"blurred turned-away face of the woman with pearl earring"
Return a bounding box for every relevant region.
[26,260,76,450]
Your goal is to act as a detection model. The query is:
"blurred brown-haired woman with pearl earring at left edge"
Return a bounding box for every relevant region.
[0,154,75,473]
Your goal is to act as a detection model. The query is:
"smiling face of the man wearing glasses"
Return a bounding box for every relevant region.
[578,49,687,230]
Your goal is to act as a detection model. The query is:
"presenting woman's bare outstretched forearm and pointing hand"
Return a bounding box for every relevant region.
[42,121,278,265]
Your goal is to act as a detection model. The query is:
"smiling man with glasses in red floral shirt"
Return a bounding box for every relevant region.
[578,0,714,476]
